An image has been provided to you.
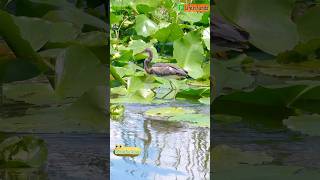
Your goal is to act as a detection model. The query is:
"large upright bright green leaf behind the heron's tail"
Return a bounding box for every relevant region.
[173,32,204,79]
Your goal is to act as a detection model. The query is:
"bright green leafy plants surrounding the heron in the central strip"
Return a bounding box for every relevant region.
[110,0,210,103]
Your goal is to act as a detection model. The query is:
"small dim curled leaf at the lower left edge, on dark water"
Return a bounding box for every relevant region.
[0,136,48,168]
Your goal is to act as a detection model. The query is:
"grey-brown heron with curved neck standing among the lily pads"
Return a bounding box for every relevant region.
[141,48,189,98]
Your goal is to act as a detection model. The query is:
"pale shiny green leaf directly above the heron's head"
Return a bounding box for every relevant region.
[135,14,158,37]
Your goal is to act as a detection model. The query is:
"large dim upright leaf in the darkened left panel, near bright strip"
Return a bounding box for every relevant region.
[55,46,107,97]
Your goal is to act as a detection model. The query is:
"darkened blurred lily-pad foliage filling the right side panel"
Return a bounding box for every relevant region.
[211,0,320,179]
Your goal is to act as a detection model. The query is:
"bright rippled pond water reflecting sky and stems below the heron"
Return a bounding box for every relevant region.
[110,102,210,180]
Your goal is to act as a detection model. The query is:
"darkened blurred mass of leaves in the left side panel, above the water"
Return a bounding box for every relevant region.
[0,0,108,133]
